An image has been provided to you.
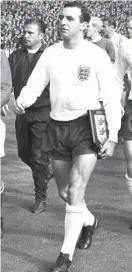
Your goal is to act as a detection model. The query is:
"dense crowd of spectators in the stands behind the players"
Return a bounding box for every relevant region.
[1,0,132,52]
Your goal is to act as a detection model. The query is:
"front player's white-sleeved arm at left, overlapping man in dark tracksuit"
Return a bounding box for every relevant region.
[16,50,49,114]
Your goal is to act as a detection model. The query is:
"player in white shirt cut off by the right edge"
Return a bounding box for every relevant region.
[115,17,132,217]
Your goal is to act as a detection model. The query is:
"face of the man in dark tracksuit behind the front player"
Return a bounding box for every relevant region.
[23,24,43,49]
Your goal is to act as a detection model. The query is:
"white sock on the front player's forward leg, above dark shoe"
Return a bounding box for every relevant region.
[61,204,85,261]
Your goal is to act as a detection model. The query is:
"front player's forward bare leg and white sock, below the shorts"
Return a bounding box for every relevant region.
[61,154,97,261]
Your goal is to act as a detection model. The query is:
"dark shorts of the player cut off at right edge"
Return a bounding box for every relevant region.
[122,100,132,140]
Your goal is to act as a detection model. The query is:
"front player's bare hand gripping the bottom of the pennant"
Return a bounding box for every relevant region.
[98,141,116,159]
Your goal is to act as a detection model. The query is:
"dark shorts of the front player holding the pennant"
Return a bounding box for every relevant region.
[48,115,97,161]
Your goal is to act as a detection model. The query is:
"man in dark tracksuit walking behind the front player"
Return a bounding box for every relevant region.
[9,18,52,213]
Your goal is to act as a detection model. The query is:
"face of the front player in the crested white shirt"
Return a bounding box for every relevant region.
[59,7,81,39]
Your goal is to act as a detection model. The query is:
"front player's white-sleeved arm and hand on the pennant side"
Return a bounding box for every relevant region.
[97,52,121,158]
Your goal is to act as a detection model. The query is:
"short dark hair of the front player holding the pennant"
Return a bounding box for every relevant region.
[64,1,90,23]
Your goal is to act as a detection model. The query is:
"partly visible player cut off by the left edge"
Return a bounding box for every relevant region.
[0,49,12,237]
